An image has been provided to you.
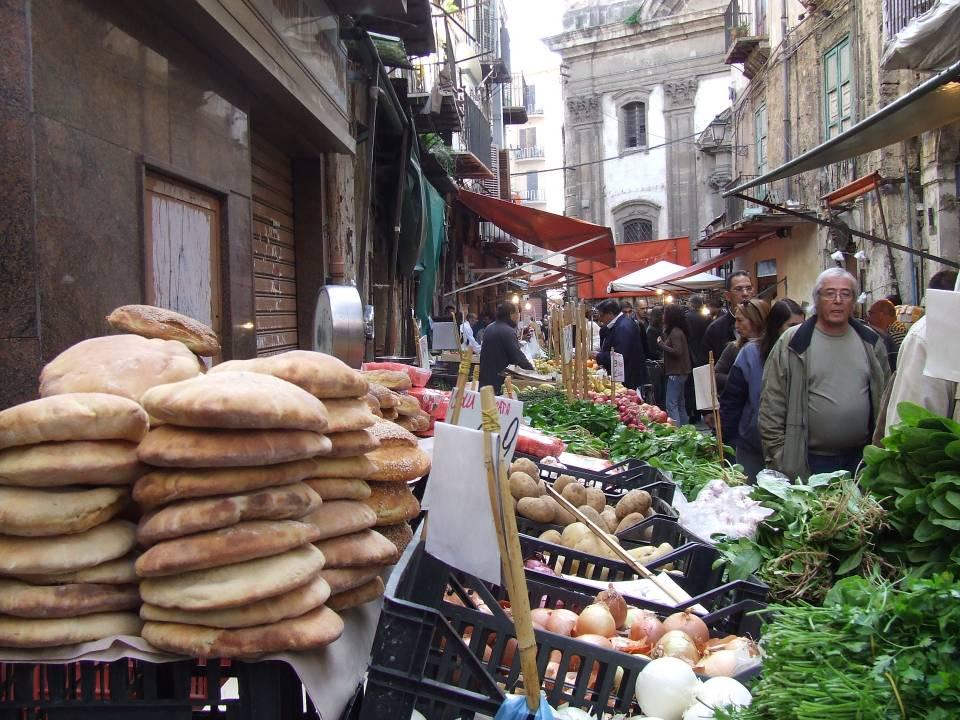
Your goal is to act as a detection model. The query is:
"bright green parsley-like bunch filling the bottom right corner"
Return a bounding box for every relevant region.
[718,574,960,720]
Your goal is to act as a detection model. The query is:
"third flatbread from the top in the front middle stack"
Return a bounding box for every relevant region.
[133,459,322,508]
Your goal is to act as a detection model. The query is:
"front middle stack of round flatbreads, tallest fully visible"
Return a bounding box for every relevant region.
[134,371,343,658]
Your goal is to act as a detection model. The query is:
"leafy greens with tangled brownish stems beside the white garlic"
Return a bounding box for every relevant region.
[717,471,895,603]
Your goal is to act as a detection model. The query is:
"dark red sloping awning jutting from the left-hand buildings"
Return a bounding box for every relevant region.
[459,188,616,267]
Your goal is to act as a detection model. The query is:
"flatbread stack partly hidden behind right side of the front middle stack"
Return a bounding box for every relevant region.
[210,350,404,611]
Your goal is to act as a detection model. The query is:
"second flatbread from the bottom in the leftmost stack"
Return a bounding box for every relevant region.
[0,578,140,618]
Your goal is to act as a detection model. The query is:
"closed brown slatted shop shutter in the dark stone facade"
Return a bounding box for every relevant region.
[251,136,297,355]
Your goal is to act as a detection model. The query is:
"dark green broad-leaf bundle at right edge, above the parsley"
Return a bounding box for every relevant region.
[860,402,960,575]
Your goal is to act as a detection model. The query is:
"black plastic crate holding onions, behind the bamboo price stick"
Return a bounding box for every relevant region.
[360,544,763,720]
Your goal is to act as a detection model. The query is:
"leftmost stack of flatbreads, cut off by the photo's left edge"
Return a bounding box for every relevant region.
[0,393,148,648]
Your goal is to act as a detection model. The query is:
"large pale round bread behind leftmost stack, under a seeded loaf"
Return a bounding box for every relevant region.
[40,335,200,401]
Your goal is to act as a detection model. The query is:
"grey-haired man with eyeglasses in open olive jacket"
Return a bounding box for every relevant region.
[759,268,890,479]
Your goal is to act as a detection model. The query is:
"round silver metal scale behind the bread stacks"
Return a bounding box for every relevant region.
[313,285,366,368]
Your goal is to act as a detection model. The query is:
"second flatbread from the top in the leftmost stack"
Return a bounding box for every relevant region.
[0,440,147,487]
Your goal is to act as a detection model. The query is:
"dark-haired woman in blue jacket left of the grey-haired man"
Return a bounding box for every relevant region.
[720,298,803,482]
